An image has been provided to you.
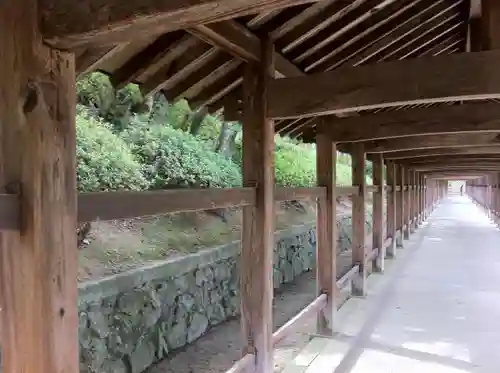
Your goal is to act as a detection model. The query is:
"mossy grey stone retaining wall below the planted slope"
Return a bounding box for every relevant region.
[78,217,370,373]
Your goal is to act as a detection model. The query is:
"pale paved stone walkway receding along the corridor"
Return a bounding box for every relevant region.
[284,196,500,373]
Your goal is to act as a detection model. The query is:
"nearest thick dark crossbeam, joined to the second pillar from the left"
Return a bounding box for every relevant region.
[269,51,500,118]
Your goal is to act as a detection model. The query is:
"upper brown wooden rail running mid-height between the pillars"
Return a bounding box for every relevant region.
[0,186,386,230]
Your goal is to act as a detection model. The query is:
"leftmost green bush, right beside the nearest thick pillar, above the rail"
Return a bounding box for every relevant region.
[76,108,148,192]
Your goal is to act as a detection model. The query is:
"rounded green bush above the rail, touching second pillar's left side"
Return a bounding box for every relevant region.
[122,117,241,189]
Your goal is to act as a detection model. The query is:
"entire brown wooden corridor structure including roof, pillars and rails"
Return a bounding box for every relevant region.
[0,0,500,373]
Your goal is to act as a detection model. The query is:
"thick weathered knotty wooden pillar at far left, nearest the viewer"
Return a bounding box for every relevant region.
[0,0,79,373]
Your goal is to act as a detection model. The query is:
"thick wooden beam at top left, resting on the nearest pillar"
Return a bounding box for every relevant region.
[40,0,322,49]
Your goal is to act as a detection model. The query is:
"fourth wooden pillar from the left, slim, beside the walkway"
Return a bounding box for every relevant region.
[351,143,366,296]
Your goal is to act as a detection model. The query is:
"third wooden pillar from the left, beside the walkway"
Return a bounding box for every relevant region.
[316,134,337,335]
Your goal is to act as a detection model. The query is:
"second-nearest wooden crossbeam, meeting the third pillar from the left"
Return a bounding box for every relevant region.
[318,102,500,142]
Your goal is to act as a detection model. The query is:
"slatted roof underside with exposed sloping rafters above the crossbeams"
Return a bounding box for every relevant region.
[76,0,470,139]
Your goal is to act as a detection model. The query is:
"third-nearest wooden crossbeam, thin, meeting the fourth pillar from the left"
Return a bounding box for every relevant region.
[348,133,500,153]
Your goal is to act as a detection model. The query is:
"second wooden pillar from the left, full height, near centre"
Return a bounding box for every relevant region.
[240,35,275,373]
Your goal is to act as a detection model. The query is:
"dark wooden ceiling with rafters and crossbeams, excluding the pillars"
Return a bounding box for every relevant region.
[63,0,500,177]
